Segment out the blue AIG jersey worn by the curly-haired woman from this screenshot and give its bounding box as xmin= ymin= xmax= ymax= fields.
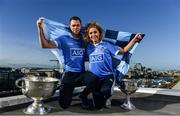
xmin=87 ymin=41 xmax=120 ymax=78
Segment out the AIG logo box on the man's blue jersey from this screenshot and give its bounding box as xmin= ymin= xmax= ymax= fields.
xmin=70 ymin=48 xmax=84 ymax=57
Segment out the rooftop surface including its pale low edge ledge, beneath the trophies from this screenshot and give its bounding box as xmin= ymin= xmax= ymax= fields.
xmin=0 ymin=88 xmax=180 ymax=115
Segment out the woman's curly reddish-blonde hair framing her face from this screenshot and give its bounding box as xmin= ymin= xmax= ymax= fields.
xmin=84 ymin=22 xmax=103 ymax=42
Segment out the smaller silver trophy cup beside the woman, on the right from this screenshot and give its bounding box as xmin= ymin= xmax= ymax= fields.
xmin=120 ymin=79 xmax=137 ymax=110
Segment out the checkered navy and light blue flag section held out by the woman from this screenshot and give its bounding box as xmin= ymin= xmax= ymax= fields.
xmin=105 ymin=30 xmax=145 ymax=83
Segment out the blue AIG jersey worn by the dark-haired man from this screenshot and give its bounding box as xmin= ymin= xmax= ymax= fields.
xmin=54 ymin=36 xmax=85 ymax=72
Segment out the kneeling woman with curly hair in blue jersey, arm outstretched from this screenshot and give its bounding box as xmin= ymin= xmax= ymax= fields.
xmin=81 ymin=22 xmax=142 ymax=109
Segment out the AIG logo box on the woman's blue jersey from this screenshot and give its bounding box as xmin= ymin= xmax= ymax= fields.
xmin=89 ymin=54 xmax=104 ymax=63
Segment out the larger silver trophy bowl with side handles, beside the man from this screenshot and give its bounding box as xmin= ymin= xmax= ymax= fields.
xmin=16 ymin=76 xmax=59 ymax=114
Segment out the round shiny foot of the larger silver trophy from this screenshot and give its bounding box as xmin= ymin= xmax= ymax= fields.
xmin=23 ymin=104 xmax=51 ymax=115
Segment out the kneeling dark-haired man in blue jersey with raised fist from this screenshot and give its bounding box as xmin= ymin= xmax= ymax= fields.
xmin=37 ymin=16 xmax=85 ymax=109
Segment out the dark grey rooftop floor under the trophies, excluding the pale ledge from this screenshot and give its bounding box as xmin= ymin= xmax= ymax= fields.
xmin=0 ymin=88 xmax=180 ymax=115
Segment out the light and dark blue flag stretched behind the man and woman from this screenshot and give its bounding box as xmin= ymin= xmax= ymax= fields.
xmin=43 ymin=18 xmax=144 ymax=82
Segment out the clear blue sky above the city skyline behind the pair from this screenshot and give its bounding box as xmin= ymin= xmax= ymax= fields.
xmin=0 ymin=0 xmax=180 ymax=70
